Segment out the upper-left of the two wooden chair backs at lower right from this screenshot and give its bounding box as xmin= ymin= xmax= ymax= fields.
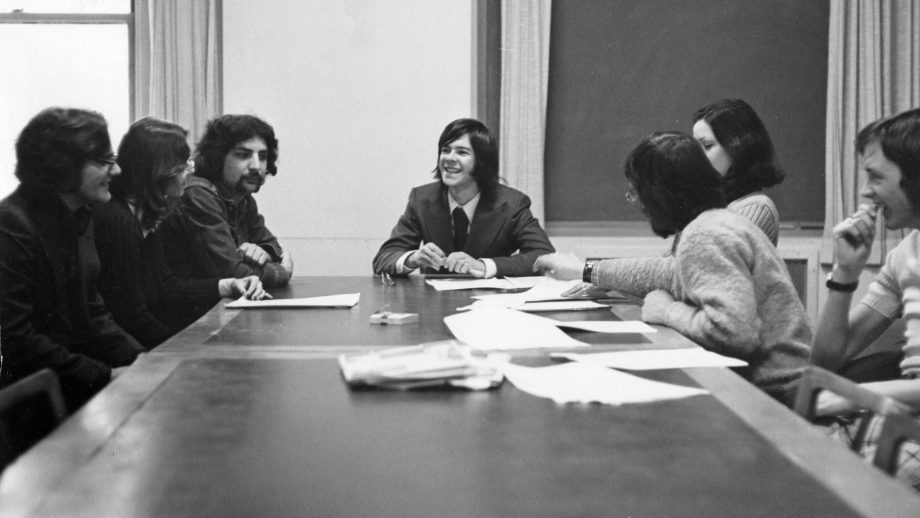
xmin=792 ymin=365 xmax=909 ymax=451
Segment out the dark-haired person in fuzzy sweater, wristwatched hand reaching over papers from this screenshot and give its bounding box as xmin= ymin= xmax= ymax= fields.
xmin=534 ymin=132 xmax=812 ymax=404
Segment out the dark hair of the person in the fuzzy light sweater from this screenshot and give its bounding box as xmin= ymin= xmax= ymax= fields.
xmin=623 ymin=131 xmax=725 ymax=241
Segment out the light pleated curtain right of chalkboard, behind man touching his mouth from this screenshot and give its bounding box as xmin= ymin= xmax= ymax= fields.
xmin=822 ymin=0 xmax=920 ymax=262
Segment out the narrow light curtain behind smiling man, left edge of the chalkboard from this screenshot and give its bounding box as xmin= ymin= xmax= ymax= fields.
xmin=499 ymin=0 xmax=552 ymax=223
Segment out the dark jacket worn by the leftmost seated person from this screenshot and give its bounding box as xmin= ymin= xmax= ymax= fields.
xmin=0 ymin=185 xmax=146 ymax=409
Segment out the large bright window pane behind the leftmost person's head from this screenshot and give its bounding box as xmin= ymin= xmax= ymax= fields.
xmin=0 ymin=24 xmax=130 ymax=197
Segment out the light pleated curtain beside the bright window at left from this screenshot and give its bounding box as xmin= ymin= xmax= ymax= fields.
xmin=134 ymin=0 xmax=222 ymax=143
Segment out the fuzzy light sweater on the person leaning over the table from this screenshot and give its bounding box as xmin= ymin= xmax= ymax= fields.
xmin=595 ymin=209 xmax=813 ymax=403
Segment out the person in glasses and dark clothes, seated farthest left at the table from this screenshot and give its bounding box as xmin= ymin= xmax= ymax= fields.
xmin=0 ymin=108 xmax=145 ymax=411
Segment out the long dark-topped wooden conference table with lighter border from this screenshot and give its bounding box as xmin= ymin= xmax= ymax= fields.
xmin=0 ymin=278 xmax=920 ymax=517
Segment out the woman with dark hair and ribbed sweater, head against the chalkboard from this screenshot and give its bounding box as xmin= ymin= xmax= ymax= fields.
xmin=693 ymin=99 xmax=786 ymax=245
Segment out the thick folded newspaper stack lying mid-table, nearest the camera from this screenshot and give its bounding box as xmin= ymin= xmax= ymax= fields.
xmin=339 ymin=341 xmax=504 ymax=390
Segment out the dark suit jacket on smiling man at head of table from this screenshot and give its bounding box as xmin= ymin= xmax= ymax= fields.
xmin=374 ymin=181 xmax=555 ymax=276
